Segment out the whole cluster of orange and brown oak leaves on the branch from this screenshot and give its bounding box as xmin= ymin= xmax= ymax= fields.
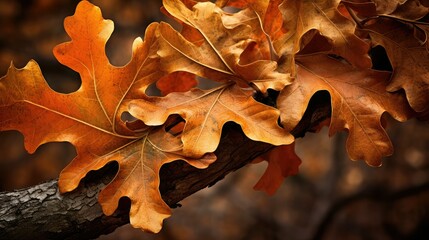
xmin=0 ymin=0 xmax=429 ymax=232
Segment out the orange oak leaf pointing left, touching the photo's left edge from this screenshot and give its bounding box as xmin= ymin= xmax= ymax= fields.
xmin=0 ymin=61 xmax=129 ymax=158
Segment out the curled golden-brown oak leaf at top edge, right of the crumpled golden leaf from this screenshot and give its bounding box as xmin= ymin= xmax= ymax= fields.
xmin=274 ymin=0 xmax=371 ymax=73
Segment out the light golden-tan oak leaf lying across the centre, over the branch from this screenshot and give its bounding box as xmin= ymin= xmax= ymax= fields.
xmin=129 ymin=84 xmax=294 ymax=158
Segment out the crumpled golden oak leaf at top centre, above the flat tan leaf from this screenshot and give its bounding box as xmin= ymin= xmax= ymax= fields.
xmin=157 ymin=0 xmax=291 ymax=92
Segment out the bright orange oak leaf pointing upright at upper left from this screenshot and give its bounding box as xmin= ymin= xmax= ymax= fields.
xmin=54 ymin=1 xmax=161 ymax=134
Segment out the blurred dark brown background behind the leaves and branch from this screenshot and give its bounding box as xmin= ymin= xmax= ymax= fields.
xmin=0 ymin=0 xmax=429 ymax=240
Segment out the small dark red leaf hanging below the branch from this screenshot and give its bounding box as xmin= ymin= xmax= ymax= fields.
xmin=253 ymin=143 xmax=301 ymax=195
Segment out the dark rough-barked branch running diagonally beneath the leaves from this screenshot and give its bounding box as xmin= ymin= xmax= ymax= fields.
xmin=0 ymin=94 xmax=330 ymax=239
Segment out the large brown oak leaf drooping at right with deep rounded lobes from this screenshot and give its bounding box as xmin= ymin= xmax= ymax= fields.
xmin=277 ymin=55 xmax=411 ymax=166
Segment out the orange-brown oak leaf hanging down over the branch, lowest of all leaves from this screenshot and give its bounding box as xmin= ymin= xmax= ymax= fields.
xmin=89 ymin=128 xmax=216 ymax=232
